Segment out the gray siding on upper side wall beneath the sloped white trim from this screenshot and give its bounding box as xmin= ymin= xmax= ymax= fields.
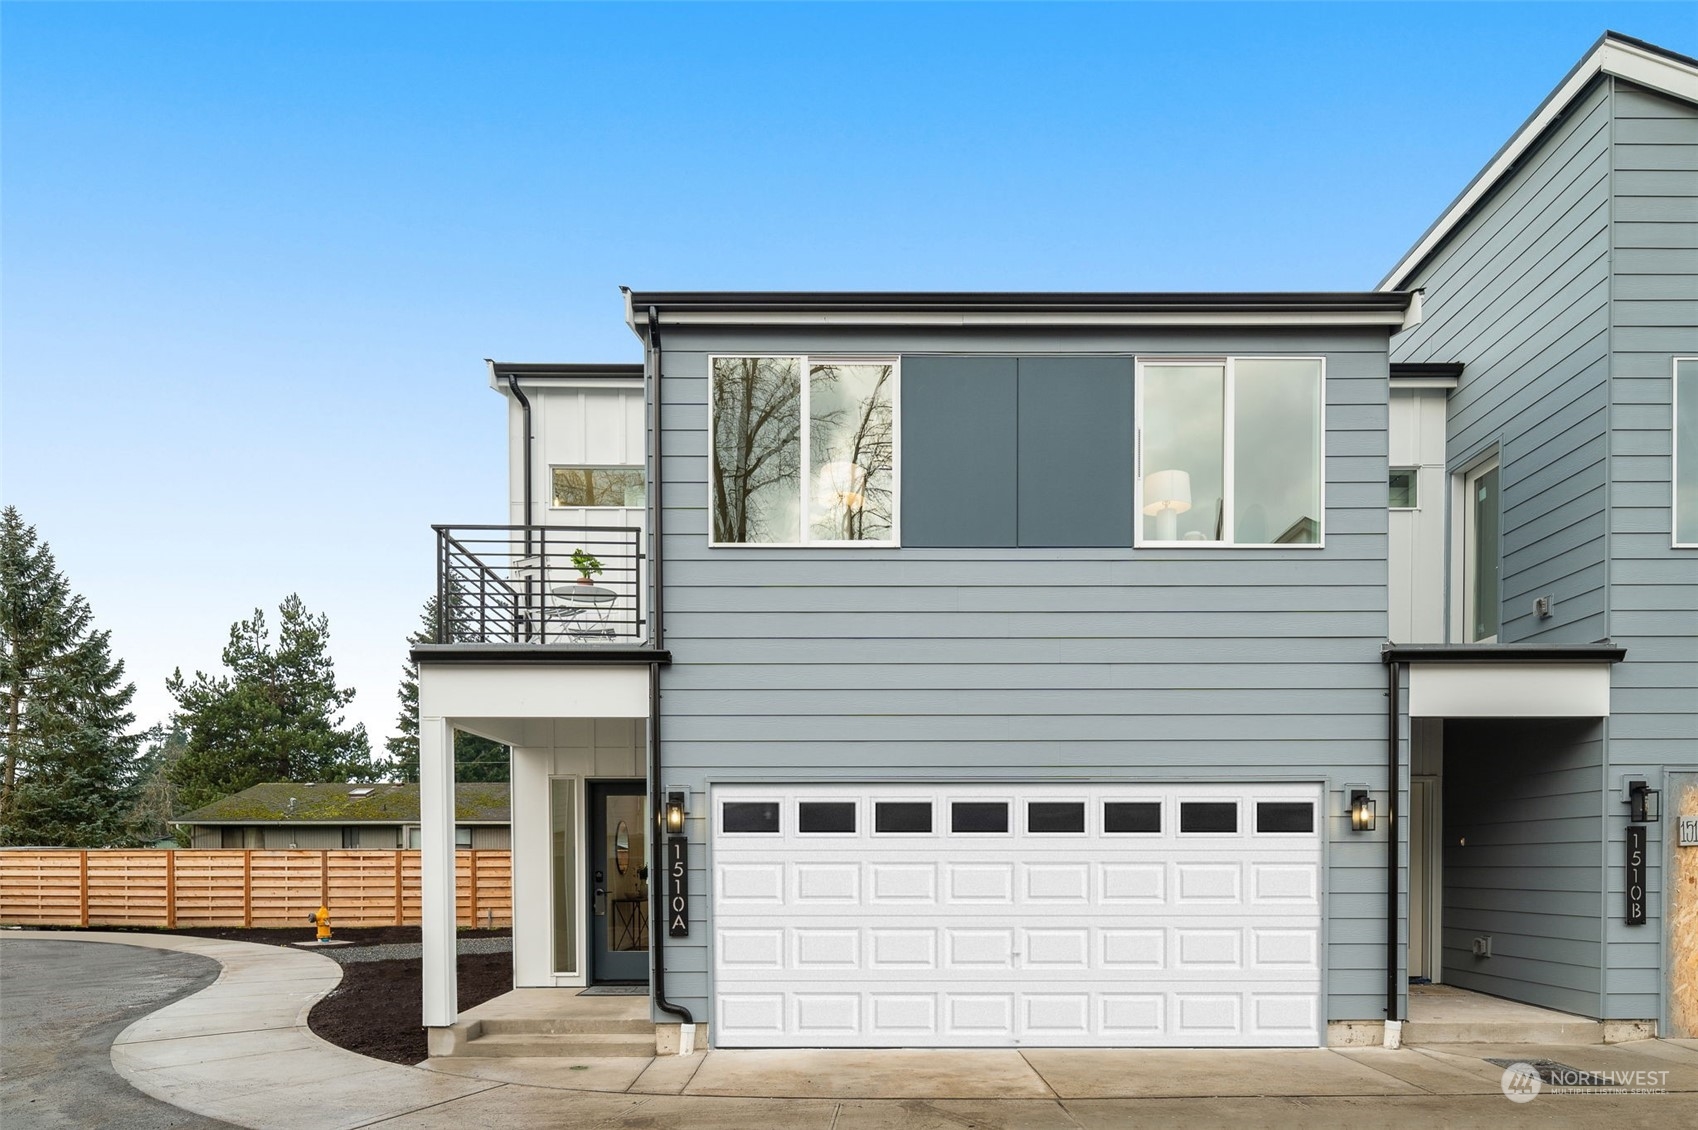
xmin=1392 ymin=83 xmax=1611 ymax=642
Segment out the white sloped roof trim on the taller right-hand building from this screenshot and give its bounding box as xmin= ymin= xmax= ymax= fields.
xmin=1375 ymin=36 xmax=1698 ymax=291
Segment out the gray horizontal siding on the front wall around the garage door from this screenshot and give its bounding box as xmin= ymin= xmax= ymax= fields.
xmin=659 ymin=328 xmax=1387 ymax=1018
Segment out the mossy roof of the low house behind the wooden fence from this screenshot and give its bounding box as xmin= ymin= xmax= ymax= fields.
xmin=173 ymin=782 xmax=509 ymax=824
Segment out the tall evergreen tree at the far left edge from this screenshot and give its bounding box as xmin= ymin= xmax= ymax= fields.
xmin=0 ymin=506 xmax=138 ymax=848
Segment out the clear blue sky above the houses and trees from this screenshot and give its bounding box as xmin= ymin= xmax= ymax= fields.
xmin=0 ymin=2 xmax=1698 ymax=746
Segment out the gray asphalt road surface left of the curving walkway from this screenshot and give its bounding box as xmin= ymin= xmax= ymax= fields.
xmin=0 ymin=936 xmax=228 ymax=1130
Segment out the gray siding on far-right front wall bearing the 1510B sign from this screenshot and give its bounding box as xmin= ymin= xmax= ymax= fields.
xmin=1605 ymin=82 xmax=1698 ymax=1018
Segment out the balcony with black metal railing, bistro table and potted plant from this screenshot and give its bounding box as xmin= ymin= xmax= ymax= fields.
xmin=431 ymin=525 xmax=649 ymax=647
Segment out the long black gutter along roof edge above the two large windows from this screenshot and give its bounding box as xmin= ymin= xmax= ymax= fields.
xmin=628 ymin=291 xmax=1411 ymax=314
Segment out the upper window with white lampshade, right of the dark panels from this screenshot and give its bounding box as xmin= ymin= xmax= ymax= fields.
xmin=1134 ymin=357 xmax=1324 ymax=545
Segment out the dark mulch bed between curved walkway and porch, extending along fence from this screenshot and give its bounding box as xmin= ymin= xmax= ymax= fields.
xmin=26 ymin=926 xmax=513 ymax=1064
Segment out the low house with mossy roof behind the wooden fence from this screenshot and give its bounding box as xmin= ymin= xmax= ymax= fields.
xmin=171 ymin=782 xmax=511 ymax=848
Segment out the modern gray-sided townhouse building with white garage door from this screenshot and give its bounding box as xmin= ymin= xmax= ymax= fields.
xmin=413 ymin=28 xmax=1698 ymax=1047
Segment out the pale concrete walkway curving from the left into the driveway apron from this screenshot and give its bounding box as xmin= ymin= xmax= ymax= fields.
xmin=0 ymin=933 xmax=1698 ymax=1130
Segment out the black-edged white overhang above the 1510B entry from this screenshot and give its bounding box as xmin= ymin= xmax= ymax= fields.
xmin=1380 ymin=642 xmax=1627 ymax=719
